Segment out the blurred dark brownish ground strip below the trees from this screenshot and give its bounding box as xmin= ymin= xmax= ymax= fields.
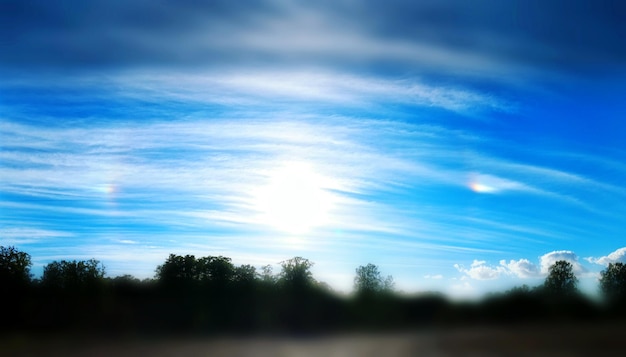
xmin=0 ymin=324 xmax=626 ymax=357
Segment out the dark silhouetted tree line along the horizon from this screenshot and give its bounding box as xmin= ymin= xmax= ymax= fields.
xmin=0 ymin=246 xmax=626 ymax=333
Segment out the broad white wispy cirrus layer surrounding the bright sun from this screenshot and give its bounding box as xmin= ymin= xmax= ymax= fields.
xmin=0 ymin=103 xmax=620 ymax=284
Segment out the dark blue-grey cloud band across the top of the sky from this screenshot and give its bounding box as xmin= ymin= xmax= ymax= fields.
xmin=0 ymin=0 xmax=626 ymax=78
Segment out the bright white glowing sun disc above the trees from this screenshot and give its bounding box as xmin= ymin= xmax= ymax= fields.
xmin=255 ymin=163 xmax=332 ymax=234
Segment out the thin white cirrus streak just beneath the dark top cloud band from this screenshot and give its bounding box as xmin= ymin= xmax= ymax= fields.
xmin=1 ymin=66 xmax=508 ymax=114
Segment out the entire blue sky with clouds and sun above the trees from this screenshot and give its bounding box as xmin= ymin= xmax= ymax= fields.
xmin=0 ymin=0 xmax=626 ymax=296
